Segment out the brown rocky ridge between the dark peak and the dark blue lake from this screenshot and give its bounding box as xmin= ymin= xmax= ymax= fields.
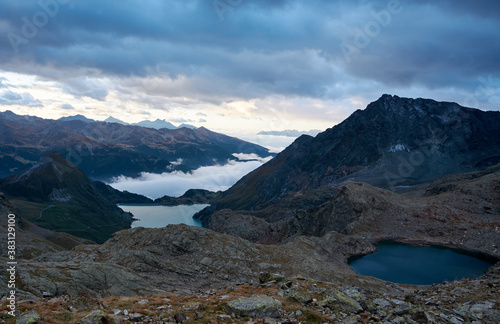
xmin=208 ymin=164 xmax=500 ymax=257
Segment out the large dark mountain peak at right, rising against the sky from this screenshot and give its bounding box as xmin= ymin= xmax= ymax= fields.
xmin=202 ymin=95 xmax=500 ymax=218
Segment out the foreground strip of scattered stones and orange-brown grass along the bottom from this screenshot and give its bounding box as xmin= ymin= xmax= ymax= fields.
xmin=1 ymin=264 xmax=500 ymax=324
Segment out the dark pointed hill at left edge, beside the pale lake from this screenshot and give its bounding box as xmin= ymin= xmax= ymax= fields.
xmin=0 ymin=153 xmax=132 ymax=243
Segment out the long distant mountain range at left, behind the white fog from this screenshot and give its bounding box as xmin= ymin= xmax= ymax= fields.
xmin=0 ymin=111 xmax=269 ymax=180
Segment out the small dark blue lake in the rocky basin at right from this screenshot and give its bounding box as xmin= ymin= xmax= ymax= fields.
xmin=349 ymin=242 xmax=493 ymax=285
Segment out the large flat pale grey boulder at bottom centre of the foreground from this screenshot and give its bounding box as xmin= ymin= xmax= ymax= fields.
xmin=226 ymin=295 xmax=281 ymax=318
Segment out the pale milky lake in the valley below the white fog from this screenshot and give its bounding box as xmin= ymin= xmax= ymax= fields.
xmin=118 ymin=204 xmax=209 ymax=228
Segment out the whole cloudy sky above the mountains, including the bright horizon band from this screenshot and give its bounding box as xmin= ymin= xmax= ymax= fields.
xmin=0 ymin=0 xmax=500 ymax=134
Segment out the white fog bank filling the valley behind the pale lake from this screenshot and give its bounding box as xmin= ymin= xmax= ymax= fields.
xmin=109 ymin=158 xmax=271 ymax=199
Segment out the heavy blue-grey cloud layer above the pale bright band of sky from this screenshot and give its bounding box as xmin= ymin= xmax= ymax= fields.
xmin=0 ymin=0 xmax=500 ymax=109
